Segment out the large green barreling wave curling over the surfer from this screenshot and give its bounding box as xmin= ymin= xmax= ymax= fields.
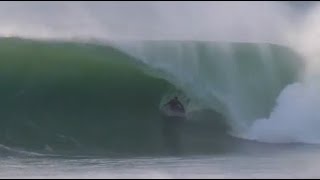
xmin=0 ymin=38 xmax=303 ymax=155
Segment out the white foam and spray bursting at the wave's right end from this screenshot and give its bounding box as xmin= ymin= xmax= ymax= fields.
xmin=245 ymin=3 xmax=320 ymax=143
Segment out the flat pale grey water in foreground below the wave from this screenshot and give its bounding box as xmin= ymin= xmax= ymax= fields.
xmin=0 ymin=145 xmax=320 ymax=179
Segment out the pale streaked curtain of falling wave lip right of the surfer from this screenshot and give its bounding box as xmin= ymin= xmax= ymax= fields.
xmin=114 ymin=41 xmax=303 ymax=136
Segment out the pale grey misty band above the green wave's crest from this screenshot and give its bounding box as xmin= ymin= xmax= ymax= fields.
xmin=0 ymin=2 xmax=292 ymax=42
